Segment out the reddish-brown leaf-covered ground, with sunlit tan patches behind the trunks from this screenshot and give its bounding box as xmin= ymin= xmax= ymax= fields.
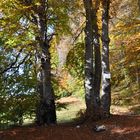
xmin=0 ymin=97 xmax=140 ymax=140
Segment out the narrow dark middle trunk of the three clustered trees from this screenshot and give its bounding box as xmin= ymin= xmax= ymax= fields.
xmin=91 ymin=3 xmax=102 ymax=115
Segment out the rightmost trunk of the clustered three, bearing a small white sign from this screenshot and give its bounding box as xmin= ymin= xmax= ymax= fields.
xmin=101 ymin=0 xmax=111 ymax=117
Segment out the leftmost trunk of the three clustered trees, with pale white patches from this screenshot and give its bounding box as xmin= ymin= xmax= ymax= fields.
xmin=83 ymin=0 xmax=93 ymax=117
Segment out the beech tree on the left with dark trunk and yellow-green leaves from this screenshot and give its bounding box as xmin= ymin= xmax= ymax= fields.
xmin=0 ymin=0 xmax=72 ymax=124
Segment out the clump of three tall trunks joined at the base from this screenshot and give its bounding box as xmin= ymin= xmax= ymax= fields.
xmin=83 ymin=0 xmax=111 ymax=119
